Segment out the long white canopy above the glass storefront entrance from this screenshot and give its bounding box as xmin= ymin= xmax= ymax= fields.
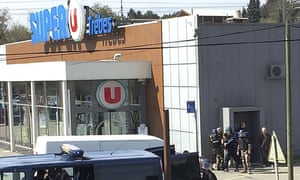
xmin=0 ymin=60 xmax=151 ymax=81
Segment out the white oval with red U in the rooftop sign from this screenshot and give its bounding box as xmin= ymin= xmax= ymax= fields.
xmin=68 ymin=0 xmax=85 ymax=41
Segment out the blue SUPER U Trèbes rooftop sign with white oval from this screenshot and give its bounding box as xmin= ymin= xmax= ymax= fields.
xmin=30 ymin=0 xmax=113 ymax=44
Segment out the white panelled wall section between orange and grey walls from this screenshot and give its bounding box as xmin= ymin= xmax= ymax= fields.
xmin=162 ymin=16 xmax=201 ymax=154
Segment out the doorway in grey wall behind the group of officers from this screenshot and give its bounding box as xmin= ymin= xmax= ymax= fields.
xmin=222 ymin=107 xmax=263 ymax=163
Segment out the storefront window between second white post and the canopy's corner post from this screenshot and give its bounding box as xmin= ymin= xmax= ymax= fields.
xmin=35 ymin=82 xmax=64 ymax=136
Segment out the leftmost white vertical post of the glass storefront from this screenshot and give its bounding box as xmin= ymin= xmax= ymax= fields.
xmin=7 ymin=81 xmax=15 ymax=152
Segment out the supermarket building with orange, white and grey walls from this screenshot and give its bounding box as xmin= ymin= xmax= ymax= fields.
xmin=0 ymin=2 xmax=300 ymax=161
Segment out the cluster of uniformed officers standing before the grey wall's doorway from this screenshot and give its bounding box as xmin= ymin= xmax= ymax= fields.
xmin=210 ymin=122 xmax=258 ymax=174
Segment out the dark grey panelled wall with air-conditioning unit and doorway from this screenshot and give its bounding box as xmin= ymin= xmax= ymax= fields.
xmin=198 ymin=24 xmax=300 ymax=158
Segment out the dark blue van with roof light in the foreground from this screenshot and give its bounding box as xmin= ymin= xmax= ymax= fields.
xmin=0 ymin=145 xmax=163 ymax=180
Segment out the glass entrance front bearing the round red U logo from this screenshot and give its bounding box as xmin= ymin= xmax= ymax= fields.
xmin=72 ymin=80 xmax=145 ymax=135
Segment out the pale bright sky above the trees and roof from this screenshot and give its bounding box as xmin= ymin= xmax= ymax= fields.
xmin=0 ymin=0 xmax=267 ymax=27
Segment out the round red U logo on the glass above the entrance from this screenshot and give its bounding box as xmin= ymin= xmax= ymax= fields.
xmin=96 ymin=81 xmax=127 ymax=109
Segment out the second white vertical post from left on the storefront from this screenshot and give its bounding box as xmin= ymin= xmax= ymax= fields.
xmin=30 ymin=81 xmax=38 ymax=149
